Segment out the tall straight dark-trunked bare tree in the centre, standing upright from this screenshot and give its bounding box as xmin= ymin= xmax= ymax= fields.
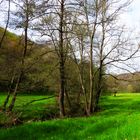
xmin=35 ymin=0 xmax=80 ymax=117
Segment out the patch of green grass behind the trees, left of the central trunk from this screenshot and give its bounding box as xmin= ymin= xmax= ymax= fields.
xmin=0 ymin=95 xmax=55 ymax=121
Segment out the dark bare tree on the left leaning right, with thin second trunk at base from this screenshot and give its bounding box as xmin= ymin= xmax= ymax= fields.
xmin=0 ymin=0 xmax=40 ymax=111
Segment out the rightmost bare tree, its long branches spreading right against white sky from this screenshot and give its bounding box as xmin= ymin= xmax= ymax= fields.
xmin=94 ymin=0 xmax=139 ymax=111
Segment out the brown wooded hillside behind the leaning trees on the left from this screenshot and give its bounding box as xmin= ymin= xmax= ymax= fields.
xmin=0 ymin=28 xmax=57 ymax=92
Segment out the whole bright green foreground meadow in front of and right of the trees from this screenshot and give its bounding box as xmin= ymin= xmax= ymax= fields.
xmin=0 ymin=94 xmax=140 ymax=140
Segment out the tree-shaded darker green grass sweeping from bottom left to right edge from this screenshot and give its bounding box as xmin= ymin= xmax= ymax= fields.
xmin=0 ymin=97 xmax=140 ymax=140
